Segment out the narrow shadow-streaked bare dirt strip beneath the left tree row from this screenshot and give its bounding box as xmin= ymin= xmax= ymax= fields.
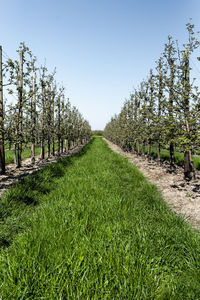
xmin=0 ymin=146 xmax=83 ymax=197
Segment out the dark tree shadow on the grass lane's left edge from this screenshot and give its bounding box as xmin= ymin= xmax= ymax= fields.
xmin=0 ymin=141 xmax=93 ymax=247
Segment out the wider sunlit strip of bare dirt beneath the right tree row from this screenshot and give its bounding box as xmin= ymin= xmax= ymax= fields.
xmin=105 ymin=139 xmax=200 ymax=229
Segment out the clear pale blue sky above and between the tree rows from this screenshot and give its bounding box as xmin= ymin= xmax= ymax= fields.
xmin=0 ymin=0 xmax=200 ymax=129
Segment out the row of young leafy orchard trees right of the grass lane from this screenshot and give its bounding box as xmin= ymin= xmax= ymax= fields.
xmin=104 ymin=23 xmax=200 ymax=179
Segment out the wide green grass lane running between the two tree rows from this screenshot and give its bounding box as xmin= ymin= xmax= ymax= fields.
xmin=0 ymin=138 xmax=200 ymax=300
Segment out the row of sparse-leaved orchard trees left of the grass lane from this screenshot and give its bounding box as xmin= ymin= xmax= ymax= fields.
xmin=0 ymin=43 xmax=91 ymax=174
